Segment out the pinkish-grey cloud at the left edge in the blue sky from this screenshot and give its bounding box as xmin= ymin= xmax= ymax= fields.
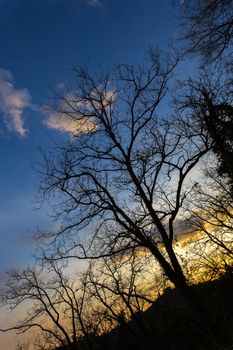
xmin=0 ymin=69 xmax=31 ymax=136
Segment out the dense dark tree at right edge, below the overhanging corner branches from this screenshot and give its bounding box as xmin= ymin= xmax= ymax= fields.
xmin=177 ymin=69 xmax=233 ymax=188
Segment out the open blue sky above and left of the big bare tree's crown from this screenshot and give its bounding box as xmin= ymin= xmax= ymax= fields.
xmin=0 ymin=0 xmax=178 ymax=350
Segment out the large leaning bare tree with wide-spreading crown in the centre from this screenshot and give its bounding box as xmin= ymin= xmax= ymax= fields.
xmin=36 ymin=51 xmax=213 ymax=295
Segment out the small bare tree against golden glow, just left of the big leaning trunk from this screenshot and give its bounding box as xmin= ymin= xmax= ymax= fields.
xmin=87 ymin=252 xmax=159 ymax=329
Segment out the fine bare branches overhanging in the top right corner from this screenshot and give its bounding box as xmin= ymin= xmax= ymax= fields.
xmin=179 ymin=0 xmax=233 ymax=63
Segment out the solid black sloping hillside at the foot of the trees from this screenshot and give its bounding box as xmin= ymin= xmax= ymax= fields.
xmin=53 ymin=272 xmax=233 ymax=350
